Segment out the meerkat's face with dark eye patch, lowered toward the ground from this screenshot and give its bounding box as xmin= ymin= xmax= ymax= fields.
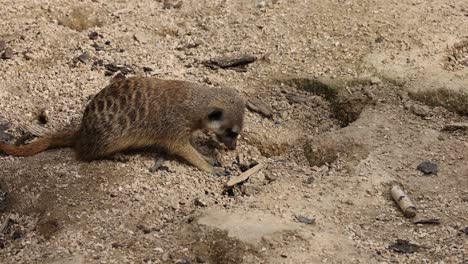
xmin=205 ymin=105 xmax=244 ymax=150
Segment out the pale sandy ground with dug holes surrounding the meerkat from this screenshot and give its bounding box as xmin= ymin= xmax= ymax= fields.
xmin=0 ymin=0 xmax=468 ymax=264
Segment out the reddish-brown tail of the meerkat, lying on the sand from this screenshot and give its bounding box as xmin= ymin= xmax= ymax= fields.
xmin=0 ymin=131 xmax=76 ymax=157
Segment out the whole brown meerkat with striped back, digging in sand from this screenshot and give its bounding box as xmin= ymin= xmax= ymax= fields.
xmin=0 ymin=77 xmax=245 ymax=174
